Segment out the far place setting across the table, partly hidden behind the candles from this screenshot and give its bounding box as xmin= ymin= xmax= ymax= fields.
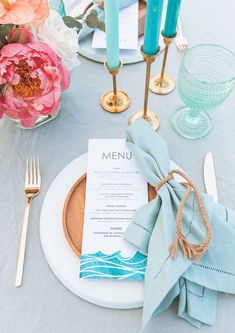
xmin=70 ymin=0 xmax=188 ymax=64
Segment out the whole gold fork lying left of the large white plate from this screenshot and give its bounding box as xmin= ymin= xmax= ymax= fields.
xmin=15 ymin=157 xmax=41 ymax=287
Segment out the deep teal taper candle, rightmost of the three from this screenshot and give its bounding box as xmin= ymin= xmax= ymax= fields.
xmin=163 ymin=0 xmax=181 ymax=38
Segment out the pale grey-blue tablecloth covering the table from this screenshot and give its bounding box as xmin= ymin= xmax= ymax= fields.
xmin=0 ymin=0 xmax=235 ymax=333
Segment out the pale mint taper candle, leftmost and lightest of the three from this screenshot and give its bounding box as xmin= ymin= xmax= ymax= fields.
xmin=104 ymin=0 xmax=119 ymax=69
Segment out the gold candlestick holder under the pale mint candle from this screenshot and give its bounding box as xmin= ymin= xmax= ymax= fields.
xmin=100 ymin=62 xmax=130 ymax=113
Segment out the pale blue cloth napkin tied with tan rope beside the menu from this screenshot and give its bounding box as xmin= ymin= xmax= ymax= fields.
xmin=125 ymin=120 xmax=235 ymax=327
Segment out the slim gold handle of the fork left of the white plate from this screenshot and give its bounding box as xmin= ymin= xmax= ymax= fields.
xmin=15 ymin=198 xmax=32 ymax=287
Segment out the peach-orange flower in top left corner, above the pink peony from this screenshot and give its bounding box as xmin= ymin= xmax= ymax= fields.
xmin=0 ymin=0 xmax=50 ymax=26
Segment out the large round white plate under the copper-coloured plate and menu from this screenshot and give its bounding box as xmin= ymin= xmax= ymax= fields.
xmin=40 ymin=154 xmax=178 ymax=309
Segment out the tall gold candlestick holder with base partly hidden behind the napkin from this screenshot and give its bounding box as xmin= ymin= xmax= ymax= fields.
xmin=128 ymin=46 xmax=160 ymax=130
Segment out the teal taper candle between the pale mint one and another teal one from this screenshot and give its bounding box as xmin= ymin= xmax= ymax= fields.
xmin=143 ymin=0 xmax=163 ymax=55
